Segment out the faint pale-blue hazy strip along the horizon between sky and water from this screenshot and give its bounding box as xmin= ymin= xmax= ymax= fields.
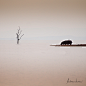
xmin=0 ymin=34 xmax=86 ymax=40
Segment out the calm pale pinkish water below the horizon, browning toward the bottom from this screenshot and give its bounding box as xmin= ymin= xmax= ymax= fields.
xmin=0 ymin=40 xmax=86 ymax=86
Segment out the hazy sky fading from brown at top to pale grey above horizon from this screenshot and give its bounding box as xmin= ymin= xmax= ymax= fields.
xmin=0 ymin=0 xmax=86 ymax=38
